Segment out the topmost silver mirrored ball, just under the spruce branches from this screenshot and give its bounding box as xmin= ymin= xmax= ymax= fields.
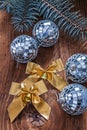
xmin=33 ymin=20 xmax=59 ymax=47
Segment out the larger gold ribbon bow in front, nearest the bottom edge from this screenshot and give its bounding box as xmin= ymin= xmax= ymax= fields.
xmin=8 ymin=78 xmax=51 ymax=122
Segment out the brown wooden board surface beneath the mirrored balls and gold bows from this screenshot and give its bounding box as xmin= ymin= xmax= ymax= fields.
xmin=0 ymin=0 xmax=87 ymax=130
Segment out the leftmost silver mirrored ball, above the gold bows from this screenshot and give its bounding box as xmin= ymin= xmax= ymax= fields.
xmin=10 ymin=35 xmax=38 ymax=63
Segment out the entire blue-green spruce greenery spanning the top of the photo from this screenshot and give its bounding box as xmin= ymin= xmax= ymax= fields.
xmin=0 ymin=0 xmax=87 ymax=40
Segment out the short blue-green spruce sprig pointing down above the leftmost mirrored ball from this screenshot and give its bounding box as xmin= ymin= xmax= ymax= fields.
xmin=12 ymin=0 xmax=39 ymax=32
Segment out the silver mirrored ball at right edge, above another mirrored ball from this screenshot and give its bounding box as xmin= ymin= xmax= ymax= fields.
xmin=65 ymin=54 xmax=87 ymax=83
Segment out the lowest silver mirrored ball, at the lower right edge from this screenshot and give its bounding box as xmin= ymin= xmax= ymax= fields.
xmin=58 ymin=83 xmax=87 ymax=115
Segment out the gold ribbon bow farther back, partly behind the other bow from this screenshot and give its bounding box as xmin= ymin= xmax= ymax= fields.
xmin=26 ymin=59 xmax=66 ymax=91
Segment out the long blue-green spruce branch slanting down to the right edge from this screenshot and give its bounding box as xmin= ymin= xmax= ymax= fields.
xmin=40 ymin=0 xmax=87 ymax=39
